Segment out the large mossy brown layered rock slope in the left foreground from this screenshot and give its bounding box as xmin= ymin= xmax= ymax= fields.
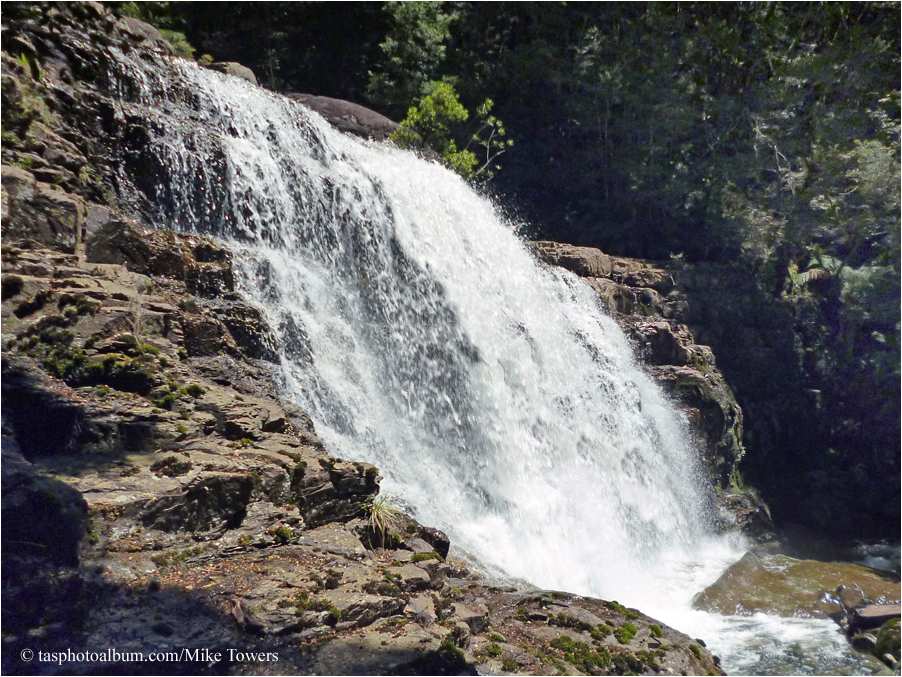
xmin=2 ymin=222 xmax=717 ymax=674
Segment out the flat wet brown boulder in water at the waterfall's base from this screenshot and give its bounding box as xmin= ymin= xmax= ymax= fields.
xmin=693 ymin=552 xmax=900 ymax=619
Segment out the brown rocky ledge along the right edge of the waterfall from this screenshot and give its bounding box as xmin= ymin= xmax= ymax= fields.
xmin=532 ymin=241 xmax=775 ymax=543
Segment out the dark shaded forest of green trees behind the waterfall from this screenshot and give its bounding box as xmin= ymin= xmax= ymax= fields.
xmin=111 ymin=2 xmax=900 ymax=537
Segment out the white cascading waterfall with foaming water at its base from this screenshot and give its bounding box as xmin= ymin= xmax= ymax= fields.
xmin=118 ymin=58 xmax=896 ymax=674
